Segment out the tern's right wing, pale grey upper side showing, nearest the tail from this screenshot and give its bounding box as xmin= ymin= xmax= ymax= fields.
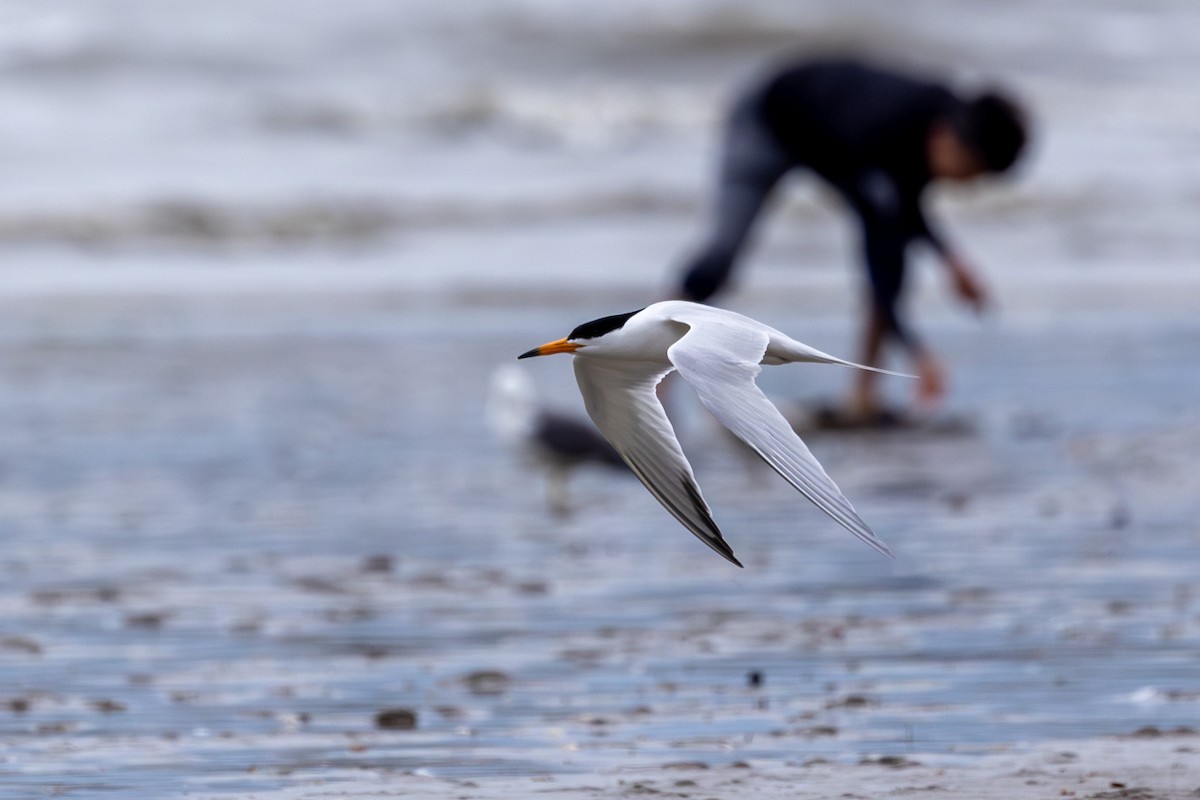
xmin=667 ymin=320 xmax=892 ymax=555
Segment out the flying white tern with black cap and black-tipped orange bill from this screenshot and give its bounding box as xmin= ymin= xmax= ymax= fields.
xmin=517 ymin=300 xmax=896 ymax=566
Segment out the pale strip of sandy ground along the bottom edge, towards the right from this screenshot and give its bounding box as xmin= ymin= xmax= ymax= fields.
xmin=184 ymin=733 xmax=1200 ymax=800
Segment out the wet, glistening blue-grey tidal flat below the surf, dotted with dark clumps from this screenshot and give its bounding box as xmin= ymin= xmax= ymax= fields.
xmin=0 ymin=278 xmax=1200 ymax=798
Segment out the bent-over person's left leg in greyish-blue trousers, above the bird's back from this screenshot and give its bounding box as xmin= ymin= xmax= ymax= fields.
xmin=682 ymin=91 xmax=793 ymax=302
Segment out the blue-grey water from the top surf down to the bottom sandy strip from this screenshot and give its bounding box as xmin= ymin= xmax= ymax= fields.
xmin=0 ymin=0 xmax=1200 ymax=798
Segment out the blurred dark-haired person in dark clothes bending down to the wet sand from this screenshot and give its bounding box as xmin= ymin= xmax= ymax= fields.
xmin=678 ymin=59 xmax=1027 ymax=423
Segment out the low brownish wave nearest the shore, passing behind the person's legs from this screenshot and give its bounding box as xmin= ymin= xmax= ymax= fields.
xmin=0 ymin=184 xmax=1142 ymax=247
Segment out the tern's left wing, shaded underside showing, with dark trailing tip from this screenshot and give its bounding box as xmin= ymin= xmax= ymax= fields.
xmin=575 ymin=357 xmax=742 ymax=566
